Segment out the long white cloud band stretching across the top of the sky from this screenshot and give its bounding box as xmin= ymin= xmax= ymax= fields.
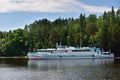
xmin=0 ymin=0 xmax=116 ymax=13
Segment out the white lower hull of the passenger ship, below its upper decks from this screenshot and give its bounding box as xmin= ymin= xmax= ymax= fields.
xmin=28 ymin=52 xmax=114 ymax=60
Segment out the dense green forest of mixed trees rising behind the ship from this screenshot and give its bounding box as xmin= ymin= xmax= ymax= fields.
xmin=0 ymin=7 xmax=120 ymax=57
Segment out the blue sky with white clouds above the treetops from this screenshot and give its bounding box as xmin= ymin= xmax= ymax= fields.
xmin=0 ymin=0 xmax=120 ymax=31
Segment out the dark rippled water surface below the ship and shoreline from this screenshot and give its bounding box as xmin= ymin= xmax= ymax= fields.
xmin=0 ymin=59 xmax=120 ymax=80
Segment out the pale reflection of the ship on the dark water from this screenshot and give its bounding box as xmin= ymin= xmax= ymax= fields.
xmin=28 ymin=59 xmax=114 ymax=70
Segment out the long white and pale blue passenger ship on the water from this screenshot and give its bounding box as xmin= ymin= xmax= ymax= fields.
xmin=28 ymin=46 xmax=114 ymax=60
